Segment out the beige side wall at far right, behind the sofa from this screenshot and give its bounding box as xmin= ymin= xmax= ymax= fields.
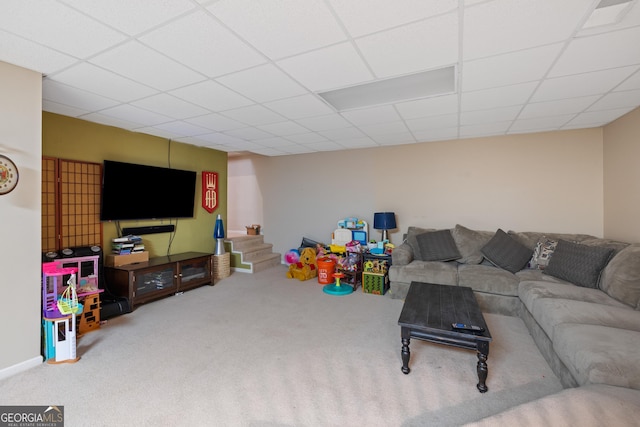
xmin=604 ymin=108 xmax=640 ymax=242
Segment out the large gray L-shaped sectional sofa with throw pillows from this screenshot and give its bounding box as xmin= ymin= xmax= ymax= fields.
xmin=389 ymin=225 xmax=640 ymax=420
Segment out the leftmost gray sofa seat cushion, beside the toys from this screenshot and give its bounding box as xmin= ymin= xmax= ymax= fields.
xmin=389 ymin=260 xmax=458 ymax=285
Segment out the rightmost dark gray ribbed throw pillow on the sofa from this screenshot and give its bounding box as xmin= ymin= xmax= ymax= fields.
xmin=543 ymin=240 xmax=613 ymax=288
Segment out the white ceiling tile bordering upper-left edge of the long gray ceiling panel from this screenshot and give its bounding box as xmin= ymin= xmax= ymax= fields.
xmin=277 ymin=43 xmax=373 ymax=91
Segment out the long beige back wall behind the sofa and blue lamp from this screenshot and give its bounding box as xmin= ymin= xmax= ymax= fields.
xmin=229 ymin=128 xmax=603 ymax=260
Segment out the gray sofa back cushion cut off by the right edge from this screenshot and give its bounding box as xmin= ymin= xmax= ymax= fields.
xmin=600 ymin=243 xmax=640 ymax=310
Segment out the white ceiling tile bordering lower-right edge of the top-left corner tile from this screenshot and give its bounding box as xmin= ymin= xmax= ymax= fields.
xmin=90 ymin=41 xmax=205 ymax=90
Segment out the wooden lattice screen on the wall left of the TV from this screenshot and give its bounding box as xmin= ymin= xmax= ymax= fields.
xmin=42 ymin=158 xmax=102 ymax=252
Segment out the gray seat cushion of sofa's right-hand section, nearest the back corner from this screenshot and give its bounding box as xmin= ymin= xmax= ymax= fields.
xmin=518 ymin=281 xmax=628 ymax=314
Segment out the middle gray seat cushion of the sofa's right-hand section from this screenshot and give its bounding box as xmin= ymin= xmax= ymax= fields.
xmin=529 ymin=298 xmax=640 ymax=345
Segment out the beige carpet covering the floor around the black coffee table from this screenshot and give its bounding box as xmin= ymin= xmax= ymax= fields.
xmin=0 ymin=266 xmax=562 ymax=426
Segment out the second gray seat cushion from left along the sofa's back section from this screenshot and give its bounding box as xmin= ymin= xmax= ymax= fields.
xmin=458 ymin=264 xmax=519 ymax=296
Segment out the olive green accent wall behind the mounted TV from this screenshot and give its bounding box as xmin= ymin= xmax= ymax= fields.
xmin=42 ymin=112 xmax=227 ymax=256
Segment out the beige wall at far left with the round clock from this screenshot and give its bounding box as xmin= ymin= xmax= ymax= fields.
xmin=0 ymin=62 xmax=42 ymax=379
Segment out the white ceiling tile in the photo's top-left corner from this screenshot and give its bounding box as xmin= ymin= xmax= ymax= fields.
xmin=0 ymin=0 xmax=125 ymax=58
